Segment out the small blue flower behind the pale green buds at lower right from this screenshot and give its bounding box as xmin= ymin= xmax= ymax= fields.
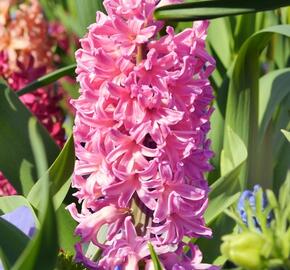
xmin=237 ymin=185 xmax=272 ymax=230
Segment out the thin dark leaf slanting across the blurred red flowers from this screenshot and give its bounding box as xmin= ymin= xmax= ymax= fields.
xmin=17 ymin=64 xmax=76 ymax=96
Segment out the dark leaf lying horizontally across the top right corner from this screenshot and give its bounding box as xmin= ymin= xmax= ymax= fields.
xmin=155 ymin=0 xmax=290 ymax=21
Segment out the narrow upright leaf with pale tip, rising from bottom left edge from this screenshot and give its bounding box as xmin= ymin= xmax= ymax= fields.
xmin=12 ymin=118 xmax=59 ymax=270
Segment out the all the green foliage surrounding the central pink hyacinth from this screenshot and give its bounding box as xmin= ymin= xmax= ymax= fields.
xmin=0 ymin=0 xmax=290 ymax=270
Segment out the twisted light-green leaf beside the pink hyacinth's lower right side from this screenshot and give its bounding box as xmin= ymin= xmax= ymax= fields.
xmin=197 ymin=127 xmax=247 ymax=262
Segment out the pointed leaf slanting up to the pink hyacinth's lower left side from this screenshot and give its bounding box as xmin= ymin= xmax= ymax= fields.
xmin=27 ymin=136 xmax=75 ymax=209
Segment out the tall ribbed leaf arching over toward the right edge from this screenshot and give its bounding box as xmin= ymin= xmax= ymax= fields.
xmin=224 ymin=25 xmax=290 ymax=186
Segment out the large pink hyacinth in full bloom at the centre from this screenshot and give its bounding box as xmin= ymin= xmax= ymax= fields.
xmin=68 ymin=0 xmax=215 ymax=269
